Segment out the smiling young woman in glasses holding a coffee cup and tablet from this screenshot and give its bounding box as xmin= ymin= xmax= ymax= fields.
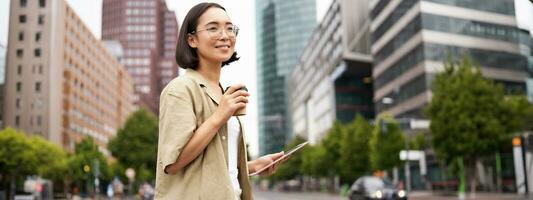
xmin=155 ymin=3 xmax=283 ymax=200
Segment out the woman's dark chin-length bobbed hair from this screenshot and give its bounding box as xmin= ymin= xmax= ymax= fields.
xmin=176 ymin=3 xmax=239 ymax=69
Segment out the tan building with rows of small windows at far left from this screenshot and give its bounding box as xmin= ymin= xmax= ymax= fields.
xmin=4 ymin=0 xmax=134 ymax=155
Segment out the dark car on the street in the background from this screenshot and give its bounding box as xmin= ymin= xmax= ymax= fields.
xmin=349 ymin=176 xmax=407 ymax=200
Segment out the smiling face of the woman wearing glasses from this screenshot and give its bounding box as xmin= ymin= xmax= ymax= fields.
xmin=188 ymin=8 xmax=236 ymax=63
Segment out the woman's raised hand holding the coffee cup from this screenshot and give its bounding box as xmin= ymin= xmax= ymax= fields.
xmin=214 ymin=84 xmax=250 ymax=123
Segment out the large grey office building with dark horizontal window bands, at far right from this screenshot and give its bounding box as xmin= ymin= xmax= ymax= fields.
xmin=370 ymin=0 xmax=530 ymax=118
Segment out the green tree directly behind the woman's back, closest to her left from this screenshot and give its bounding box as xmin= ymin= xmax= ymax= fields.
xmin=108 ymin=109 xmax=158 ymax=182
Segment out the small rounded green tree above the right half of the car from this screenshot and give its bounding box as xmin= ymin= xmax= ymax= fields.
xmin=370 ymin=116 xmax=405 ymax=170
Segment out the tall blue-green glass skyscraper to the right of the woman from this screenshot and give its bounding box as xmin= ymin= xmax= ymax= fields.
xmin=256 ymin=0 xmax=316 ymax=155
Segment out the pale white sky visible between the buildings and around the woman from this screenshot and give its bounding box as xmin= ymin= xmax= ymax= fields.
xmin=0 ymin=0 xmax=533 ymax=156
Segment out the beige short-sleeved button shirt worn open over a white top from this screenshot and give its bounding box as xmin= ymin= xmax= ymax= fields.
xmin=155 ymin=69 xmax=252 ymax=200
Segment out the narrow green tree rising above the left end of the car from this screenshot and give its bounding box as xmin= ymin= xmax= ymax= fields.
xmin=338 ymin=115 xmax=372 ymax=183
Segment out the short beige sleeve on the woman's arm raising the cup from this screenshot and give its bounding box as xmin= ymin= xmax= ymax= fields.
xmin=158 ymin=87 xmax=197 ymax=173
